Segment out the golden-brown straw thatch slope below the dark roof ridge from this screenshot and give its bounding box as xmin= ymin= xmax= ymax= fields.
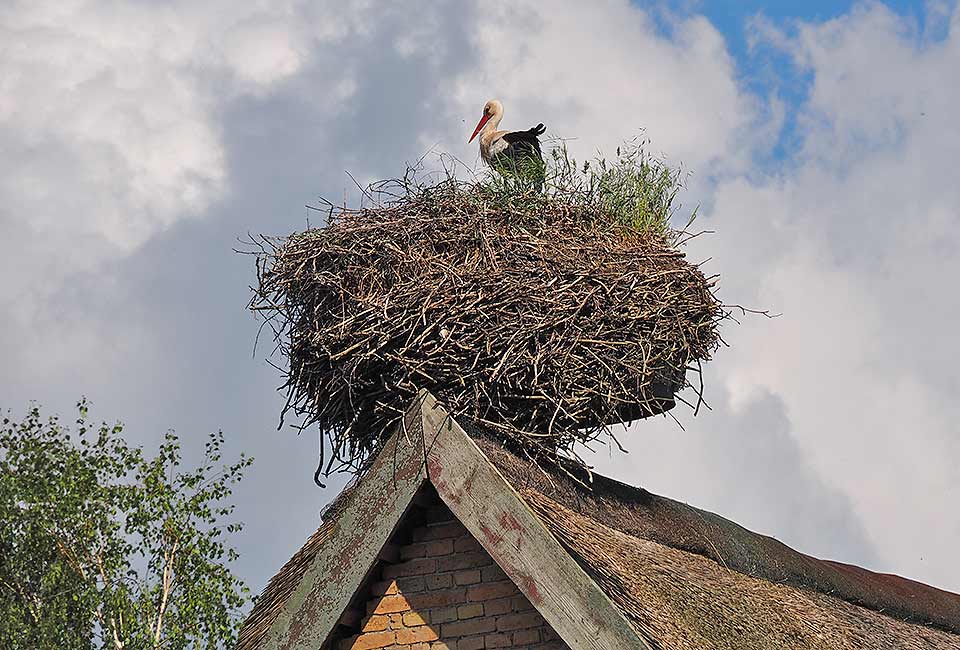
xmin=523 ymin=491 xmax=960 ymax=650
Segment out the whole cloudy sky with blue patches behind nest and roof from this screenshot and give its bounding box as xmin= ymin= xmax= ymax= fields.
xmin=0 ymin=0 xmax=960 ymax=591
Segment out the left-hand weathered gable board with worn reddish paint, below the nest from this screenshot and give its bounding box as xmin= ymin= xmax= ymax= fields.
xmin=265 ymin=400 xmax=426 ymax=650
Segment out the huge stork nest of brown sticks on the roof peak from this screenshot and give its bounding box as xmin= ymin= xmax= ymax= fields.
xmin=251 ymin=175 xmax=725 ymax=473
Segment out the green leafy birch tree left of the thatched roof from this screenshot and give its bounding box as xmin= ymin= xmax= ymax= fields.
xmin=0 ymin=402 xmax=252 ymax=650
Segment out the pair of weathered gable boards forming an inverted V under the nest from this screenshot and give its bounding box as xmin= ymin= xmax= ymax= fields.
xmin=256 ymin=392 xmax=649 ymax=650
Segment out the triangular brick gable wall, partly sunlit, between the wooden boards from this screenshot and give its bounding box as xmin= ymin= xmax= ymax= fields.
xmin=333 ymin=494 xmax=567 ymax=650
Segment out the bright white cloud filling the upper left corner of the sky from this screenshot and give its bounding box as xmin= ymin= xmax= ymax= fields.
xmin=0 ymin=0 xmax=352 ymax=271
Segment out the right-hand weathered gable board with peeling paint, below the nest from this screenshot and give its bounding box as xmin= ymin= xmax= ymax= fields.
xmin=423 ymin=395 xmax=649 ymax=650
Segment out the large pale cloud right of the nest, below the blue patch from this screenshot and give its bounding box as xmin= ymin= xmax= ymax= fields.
xmin=664 ymin=4 xmax=960 ymax=589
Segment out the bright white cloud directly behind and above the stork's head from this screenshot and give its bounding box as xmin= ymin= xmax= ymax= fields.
xmin=442 ymin=0 xmax=763 ymax=175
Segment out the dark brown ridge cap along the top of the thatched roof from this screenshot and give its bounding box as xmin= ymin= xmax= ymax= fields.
xmin=474 ymin=432 xmax=960 ymax=634
